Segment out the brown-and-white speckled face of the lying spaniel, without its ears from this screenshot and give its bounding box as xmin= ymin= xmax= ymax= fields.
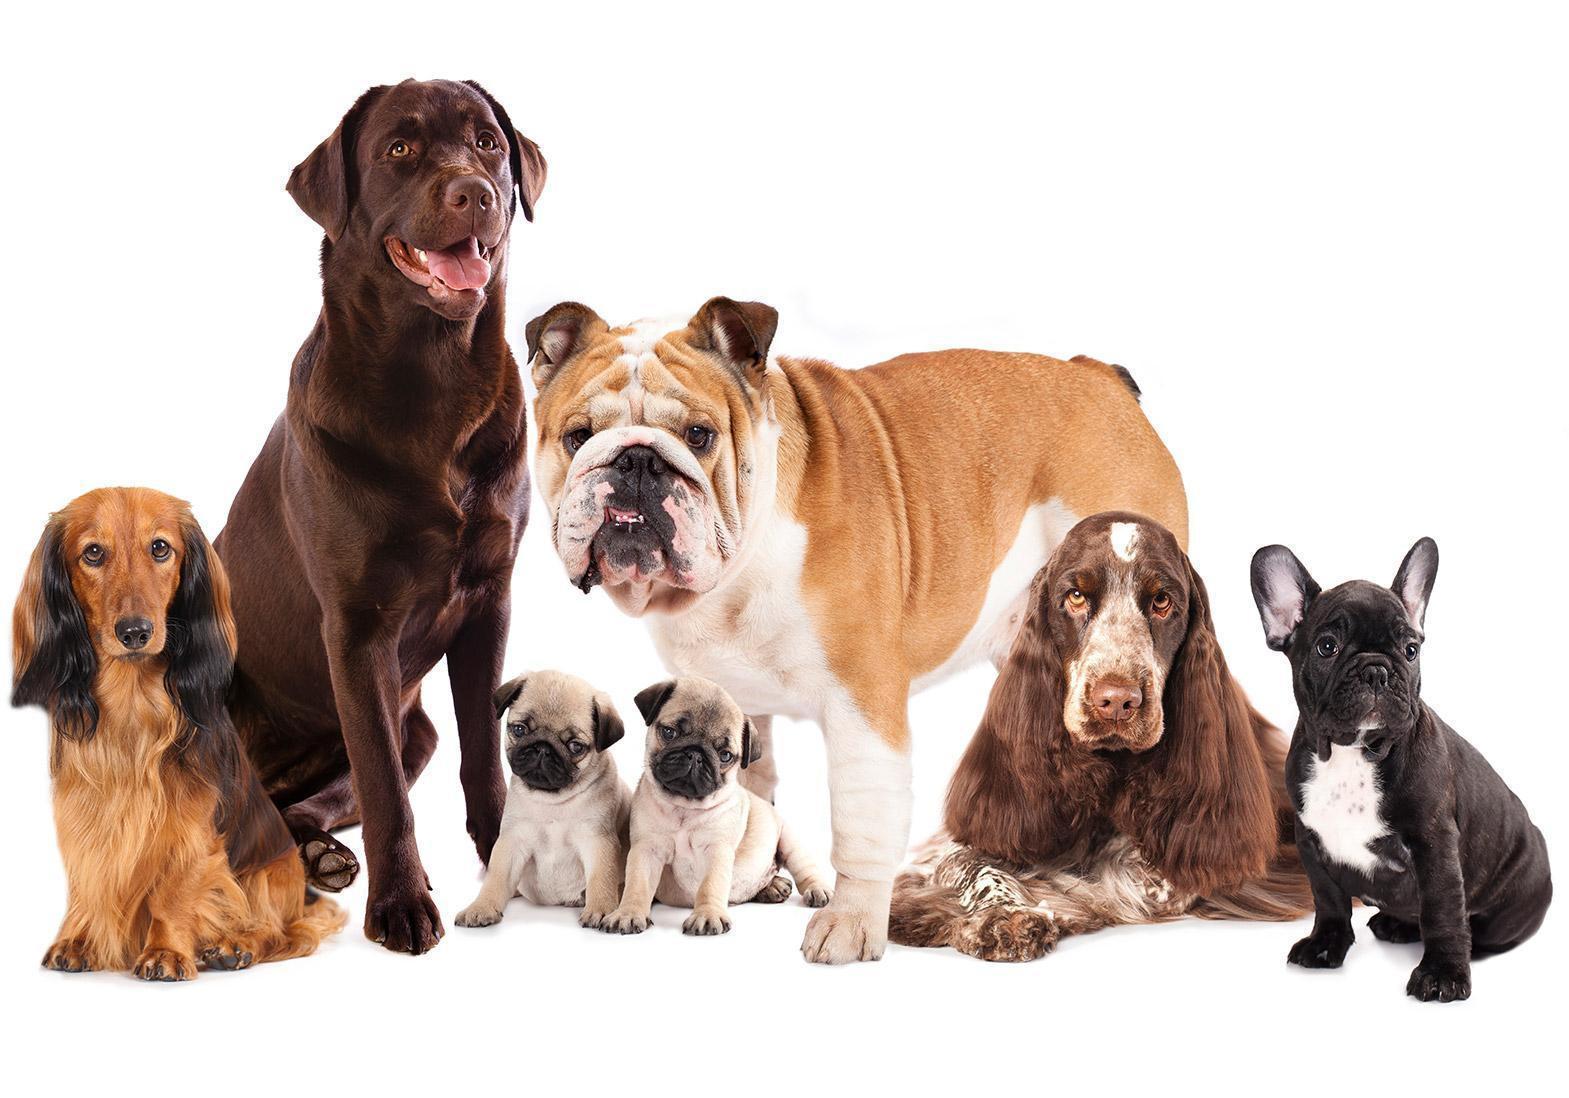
xmin=1040 ymin=511 xmax=1196 ymax=751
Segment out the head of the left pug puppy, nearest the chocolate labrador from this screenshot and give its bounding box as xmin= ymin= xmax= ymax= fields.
xmin=494 ymin=671 xmax=624 ymax=794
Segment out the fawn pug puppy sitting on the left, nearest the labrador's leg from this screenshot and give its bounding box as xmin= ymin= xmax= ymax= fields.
xmin=458 ymin=671 xmax=632 ymax=927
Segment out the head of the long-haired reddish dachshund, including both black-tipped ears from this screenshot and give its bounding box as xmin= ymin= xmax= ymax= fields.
xmin=11 ymin=488 xmax=235 ymax=736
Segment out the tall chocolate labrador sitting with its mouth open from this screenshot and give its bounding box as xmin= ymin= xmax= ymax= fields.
xmin=218 ymin=80 xmax=544 ymax=954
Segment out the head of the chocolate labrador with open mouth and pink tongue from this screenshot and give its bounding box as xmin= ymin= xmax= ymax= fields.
xmin=289 ymin=80 xmax=544 ymax=320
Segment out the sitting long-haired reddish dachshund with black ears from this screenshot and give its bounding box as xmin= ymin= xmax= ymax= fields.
xmin=11 ymin=488 xmax=344 ymax=980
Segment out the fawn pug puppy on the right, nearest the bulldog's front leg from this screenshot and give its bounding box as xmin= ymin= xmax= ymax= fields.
xmin=602 ymin=676 xmax=833 ymax=935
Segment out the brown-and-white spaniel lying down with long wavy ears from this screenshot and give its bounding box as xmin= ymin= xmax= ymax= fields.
xmin=891 ymin=511 xmax=1312 ymax=962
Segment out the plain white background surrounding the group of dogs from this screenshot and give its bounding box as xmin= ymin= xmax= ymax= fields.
xmin=0 ymin=0 xmax=1569 ymax=1093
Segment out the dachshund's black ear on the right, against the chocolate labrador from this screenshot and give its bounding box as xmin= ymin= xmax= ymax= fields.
xmin=163 ymin=518 xmax=235 ymax=731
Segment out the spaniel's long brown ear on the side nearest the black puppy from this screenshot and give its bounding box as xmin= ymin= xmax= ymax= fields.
xmin=1117 ymin=563 xmax=1279 ymax=894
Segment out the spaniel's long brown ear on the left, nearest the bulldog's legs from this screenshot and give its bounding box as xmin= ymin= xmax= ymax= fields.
xmin=943 ymin=569 xmax=1112 ymax=864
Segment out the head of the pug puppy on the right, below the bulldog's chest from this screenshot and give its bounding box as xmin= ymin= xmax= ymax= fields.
xmin=637 ymin=676 xmax=761 ymax=802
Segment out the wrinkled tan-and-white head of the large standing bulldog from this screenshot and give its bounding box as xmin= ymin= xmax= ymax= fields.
xmin=529 ymin=298 xmax=778 ymax=615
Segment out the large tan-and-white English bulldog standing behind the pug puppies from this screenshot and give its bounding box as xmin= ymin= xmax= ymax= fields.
xmin=527 ymin=298 xmax=1188 ymax=963
